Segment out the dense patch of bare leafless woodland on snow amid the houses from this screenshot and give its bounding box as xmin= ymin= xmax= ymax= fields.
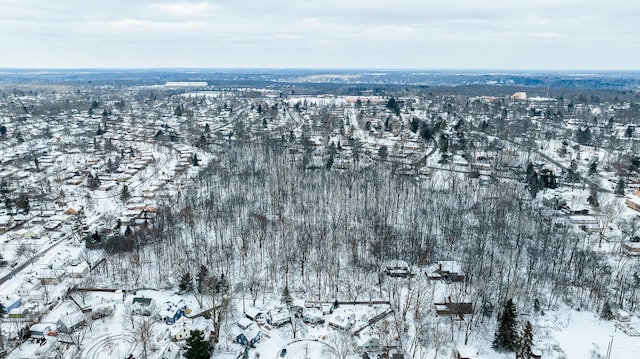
xmin=90 ymin=136 xmax=640 ymax=346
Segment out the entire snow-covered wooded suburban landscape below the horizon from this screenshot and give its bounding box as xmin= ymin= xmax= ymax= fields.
xmin=0 ymin=70 xmax=640 ymax=359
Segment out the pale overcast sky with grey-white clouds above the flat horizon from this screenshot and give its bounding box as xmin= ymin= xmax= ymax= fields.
xmin=0 ymin=0 xmax=640 ymax=70
